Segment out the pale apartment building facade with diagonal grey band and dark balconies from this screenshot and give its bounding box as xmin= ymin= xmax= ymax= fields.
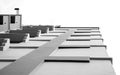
xmin=0 ymin=25 xmax=115 ymax=75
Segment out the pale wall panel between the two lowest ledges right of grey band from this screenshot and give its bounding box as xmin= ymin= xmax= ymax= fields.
xmin=50 ymin=47 xmax=108 ymax=57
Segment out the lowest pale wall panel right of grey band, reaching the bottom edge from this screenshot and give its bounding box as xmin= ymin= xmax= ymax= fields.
xmin=29 ymin=60 xmax=115 ymax=75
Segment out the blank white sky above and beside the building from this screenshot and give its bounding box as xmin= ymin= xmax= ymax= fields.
xmin=0 ymin=0 xmax=120 ymax=75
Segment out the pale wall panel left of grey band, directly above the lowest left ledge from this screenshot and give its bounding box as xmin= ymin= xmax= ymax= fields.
xmin=0 ymin=48 xmax=36 ymax=60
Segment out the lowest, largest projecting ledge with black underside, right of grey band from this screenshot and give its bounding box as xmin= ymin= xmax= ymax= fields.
xmin=44 ymin=56 xmax=112 ymax=63
